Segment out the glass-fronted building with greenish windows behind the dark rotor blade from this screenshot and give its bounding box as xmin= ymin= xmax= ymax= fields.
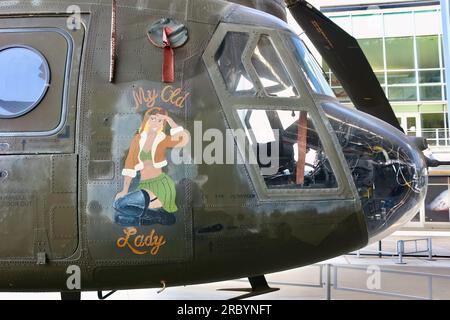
xmin=320 ymin=1 xmax=450 ymax=229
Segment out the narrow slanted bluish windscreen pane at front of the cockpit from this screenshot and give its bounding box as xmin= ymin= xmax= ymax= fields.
xmin=287 ymin=35 xmax=335 ymax=97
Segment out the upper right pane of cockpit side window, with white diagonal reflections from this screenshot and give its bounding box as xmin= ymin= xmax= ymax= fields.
xmin=251 ymin=34 xmax=298 ymax=98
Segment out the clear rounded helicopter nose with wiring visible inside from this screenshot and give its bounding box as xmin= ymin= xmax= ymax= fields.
xmin=323 ymin=103 xmax=428 ymax=243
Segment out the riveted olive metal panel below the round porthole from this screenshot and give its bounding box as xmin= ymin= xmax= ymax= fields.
xmin=0 ymin=155 xmax=77 ymax=260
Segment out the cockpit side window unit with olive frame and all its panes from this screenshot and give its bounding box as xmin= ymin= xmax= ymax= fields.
xmin=203 ymin=23 xmax=353 ymax=201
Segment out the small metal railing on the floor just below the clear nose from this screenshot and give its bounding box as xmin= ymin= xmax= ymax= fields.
xmin=356 ymin=238 xmax=433 ymax=264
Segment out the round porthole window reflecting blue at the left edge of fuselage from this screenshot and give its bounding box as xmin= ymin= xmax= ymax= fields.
xmin=0 ymin=46 xmax=50 ymax=118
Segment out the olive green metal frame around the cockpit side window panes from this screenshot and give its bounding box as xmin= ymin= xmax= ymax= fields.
xmin=203 ymin=23 xmax=357 ymax=201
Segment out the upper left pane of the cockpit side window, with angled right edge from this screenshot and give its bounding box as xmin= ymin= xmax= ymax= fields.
xmin=215 ymin=32 xmax=256 ymax=95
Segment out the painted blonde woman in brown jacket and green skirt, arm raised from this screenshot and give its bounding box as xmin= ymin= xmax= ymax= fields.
xmin=114 ymin=107 xmax=189 ymax=226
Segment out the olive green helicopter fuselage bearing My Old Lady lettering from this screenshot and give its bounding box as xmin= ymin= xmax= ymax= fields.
xmin=0 ymin=0 xmax=368 ymax=291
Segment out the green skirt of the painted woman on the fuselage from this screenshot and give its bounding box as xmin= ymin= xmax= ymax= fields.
xmin=139 ymin=173 xmax=178 ymax=213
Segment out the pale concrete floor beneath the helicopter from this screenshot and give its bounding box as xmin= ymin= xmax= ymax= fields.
xmin=0 ymin=232 xmax=450 ymax=300
